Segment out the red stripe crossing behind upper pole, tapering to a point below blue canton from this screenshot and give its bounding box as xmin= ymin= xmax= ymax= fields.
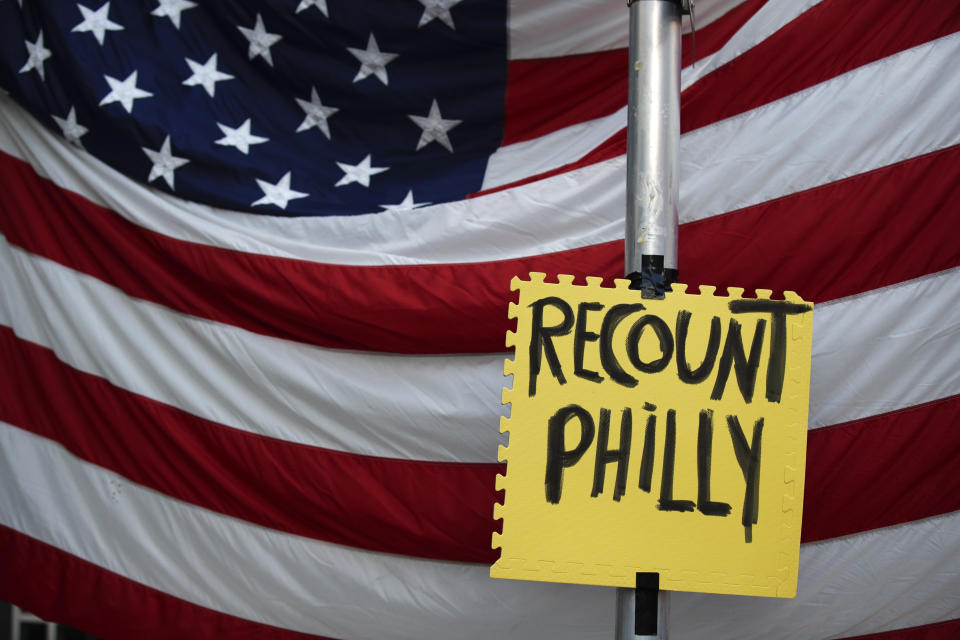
xmin=488 ymin=0 xmax=960 ymax=190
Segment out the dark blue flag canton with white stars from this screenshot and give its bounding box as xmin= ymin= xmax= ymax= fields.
xmin=0 ymin=0 xmax=506 ymax=216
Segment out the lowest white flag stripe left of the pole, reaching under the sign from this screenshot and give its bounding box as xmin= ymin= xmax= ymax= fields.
xmin=0 ymin=422 xmax=614 ymax=640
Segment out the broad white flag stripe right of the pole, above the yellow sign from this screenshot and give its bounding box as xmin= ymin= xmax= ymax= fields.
xmin=680 ymin=32 xmax=960 ymax=225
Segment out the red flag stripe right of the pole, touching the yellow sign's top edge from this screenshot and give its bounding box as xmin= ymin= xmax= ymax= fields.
xmin=679 ymin=146 xmax=960 ymax=302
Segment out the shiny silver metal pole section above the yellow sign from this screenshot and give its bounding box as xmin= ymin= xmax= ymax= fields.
xmin=625 ymin=0 xmax=681 ymax=282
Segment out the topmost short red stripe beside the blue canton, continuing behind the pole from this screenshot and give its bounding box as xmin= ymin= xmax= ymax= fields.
xmin=501 ymin=0 xmax=767 ymax=145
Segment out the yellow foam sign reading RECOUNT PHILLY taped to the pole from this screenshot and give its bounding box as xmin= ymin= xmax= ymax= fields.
xmin=490 ymin=273 xmax=813 ymax=597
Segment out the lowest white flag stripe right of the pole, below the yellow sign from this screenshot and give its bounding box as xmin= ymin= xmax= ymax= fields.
xmin=670 ymin=516 xmax=960 ymax=640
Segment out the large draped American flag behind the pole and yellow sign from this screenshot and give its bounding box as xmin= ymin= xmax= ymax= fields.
xmin=0 ymin=0 xmax=960 ymax=640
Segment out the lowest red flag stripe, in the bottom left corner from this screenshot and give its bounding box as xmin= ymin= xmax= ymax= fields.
xmin=0 ymin=525 xmax=330 ymax=640
